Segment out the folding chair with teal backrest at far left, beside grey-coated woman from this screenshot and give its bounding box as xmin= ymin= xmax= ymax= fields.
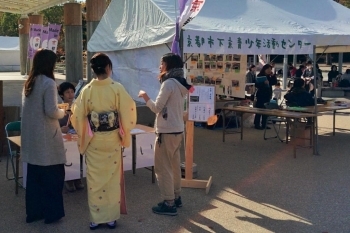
xmin=5 ymin=121 xmax=22 ymax=190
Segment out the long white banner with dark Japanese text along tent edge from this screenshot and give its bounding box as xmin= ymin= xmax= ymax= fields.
xmin=183 ymin=30 xmax=314 ymax=54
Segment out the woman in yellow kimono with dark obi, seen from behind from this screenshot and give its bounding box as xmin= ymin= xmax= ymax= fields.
xmin=71 ymin=53 xmax=136 ymax=230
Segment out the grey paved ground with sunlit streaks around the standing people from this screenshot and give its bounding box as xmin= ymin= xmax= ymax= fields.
xmin=0 ymin=74 xmax=350 ymax=233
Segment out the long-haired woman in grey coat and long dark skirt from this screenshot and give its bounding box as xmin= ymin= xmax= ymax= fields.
xmin=21 ymin=49 xmax=66 ymax=224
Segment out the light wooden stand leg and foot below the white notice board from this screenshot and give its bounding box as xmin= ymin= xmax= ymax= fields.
xmin=181 ymin=121 xmax=212 ymax=194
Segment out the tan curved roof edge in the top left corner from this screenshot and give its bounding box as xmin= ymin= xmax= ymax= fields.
xmin=0 ymin=0 xmax=67 ymax=14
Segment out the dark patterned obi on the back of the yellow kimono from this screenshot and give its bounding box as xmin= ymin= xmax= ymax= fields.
xmin=88 ymin=111 xmax=119 ymax=132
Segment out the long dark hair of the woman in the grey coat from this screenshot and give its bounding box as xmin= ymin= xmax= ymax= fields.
xmin=24 ymin=49 xmax=57 ymax=97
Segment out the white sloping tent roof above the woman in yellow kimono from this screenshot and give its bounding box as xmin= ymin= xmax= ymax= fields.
xmin=88 ymin=0 xmax=177 ymax=52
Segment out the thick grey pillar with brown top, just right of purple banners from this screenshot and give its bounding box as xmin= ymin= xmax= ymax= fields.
xmin=64 ymin=2 xmax=83 ymax=83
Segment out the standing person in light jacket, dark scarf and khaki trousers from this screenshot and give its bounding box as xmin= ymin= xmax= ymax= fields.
xmin=139 ymin=53 xmax=192 ymax=216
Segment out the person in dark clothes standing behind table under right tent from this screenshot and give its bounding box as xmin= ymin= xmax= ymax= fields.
xmin=254 ymin=64 xmax=277 ymax=130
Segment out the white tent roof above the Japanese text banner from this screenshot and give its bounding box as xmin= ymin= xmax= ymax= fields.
xmin=185 ymin=0 xmax=350 ymax=45
